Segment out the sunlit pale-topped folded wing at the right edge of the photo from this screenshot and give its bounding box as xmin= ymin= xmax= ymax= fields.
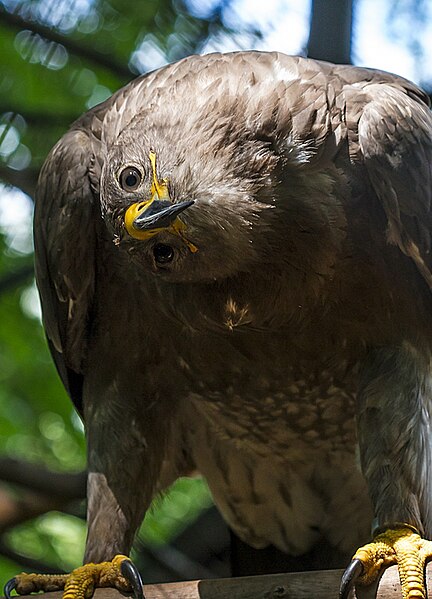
xmin=358 ymin=78 xmax=432 ymax=290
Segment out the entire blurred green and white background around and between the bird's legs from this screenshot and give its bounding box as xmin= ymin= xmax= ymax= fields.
xmin=0 ymin=0 xmax=432 ymax=582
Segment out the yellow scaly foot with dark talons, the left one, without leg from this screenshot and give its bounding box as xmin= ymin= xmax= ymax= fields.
xmin=4 ymin=555 xmax=144 ymax=599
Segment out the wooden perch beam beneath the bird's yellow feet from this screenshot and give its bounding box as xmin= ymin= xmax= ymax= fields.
xmin=9 ymin=563 xmax=432 ymax=599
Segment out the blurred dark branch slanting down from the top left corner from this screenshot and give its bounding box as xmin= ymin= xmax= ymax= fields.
xmin=0 ymin=3 xmax=136 ymax=83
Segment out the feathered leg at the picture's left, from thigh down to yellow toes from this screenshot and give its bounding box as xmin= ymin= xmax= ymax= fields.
xmin=4 ymin=359 xmax=169 ymax=599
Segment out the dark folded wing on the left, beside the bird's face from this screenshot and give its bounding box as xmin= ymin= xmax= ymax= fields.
xmin=34 ymin=130 xmax=100 ymax=410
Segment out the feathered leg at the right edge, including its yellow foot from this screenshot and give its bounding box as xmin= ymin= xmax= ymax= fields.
xmin=340 ymin=344 xmax=432 ymax=599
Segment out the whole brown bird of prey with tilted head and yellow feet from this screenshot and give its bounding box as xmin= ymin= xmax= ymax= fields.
xmin=7 ymin=51 xmax=432 ymax=599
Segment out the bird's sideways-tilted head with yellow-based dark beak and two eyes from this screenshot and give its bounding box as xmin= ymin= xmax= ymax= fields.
xmin=100 ymin=119 xmax=275 ymax=282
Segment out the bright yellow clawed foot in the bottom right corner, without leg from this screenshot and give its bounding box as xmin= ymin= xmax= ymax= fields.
xmin=339 ymin=525 xmax=432 ymax=599
